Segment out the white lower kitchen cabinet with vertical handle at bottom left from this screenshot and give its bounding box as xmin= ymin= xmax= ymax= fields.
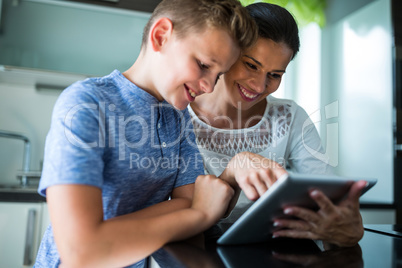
xmin=0 ymin=202 xmax=49 ymax=268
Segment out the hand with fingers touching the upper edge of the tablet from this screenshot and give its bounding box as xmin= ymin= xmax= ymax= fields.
xmin=220 ymin=152 xmax=287 ymax=200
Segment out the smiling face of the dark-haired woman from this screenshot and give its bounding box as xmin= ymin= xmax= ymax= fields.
xmin=217 ymin=38 xmax=293 ymax=110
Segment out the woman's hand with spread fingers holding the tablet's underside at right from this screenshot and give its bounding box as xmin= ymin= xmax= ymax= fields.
xmin=273 ymin=181 xmax=367 ymax=247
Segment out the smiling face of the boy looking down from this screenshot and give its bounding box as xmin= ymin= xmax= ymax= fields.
xmin=155 ymin=28 xmax=240 ymax=110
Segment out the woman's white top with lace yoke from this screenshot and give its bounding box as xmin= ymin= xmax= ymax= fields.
xmin=188 ymin=96 xmax=333 ymax=223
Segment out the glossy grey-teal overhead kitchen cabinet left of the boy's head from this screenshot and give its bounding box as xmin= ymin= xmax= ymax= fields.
xmin=0 ymin=0 xmax=151 ymax=77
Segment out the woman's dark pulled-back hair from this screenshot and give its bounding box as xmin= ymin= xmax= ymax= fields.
xmin=246 ymin=3 xmax=300 ymax=59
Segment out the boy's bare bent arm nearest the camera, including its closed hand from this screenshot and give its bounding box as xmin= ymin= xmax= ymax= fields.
xmin=47 ymin=176 xmax=233 ymax=267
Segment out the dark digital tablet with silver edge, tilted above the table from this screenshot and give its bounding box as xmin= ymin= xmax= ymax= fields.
xmin=217 ymin=174 xmax=377 ymax=245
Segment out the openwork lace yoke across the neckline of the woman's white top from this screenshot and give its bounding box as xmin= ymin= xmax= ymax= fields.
xmin=190 ymin=103 xmax=292 ymax=157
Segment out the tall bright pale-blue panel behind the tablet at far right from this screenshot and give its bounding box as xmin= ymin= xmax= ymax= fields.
xmin=322 ymin=0 xmax=393 ymax=204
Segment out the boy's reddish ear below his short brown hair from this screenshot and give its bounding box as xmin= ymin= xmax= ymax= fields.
xmin=150 ymin=18 xmax=173 ymax=51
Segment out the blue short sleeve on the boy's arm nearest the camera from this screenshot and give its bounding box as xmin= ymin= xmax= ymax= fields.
xmin=38 ymin=83 xmax=104 ymax=196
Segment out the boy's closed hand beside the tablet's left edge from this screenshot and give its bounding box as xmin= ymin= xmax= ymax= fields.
xmin=192 ymin=175 xmax=234 ymax=226
